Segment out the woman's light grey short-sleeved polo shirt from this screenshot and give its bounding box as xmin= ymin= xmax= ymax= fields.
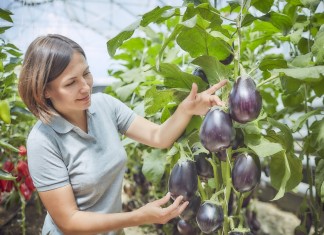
xmin=27 ymin=93 xmax=135 ymax=235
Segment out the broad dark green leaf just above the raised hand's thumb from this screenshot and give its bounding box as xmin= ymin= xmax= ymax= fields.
xmin=157 ymin=63 xmax=206 ymax=91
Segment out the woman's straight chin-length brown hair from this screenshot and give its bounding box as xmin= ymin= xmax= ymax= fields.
xmin=18 ymin=34 xmax=86 ymax=123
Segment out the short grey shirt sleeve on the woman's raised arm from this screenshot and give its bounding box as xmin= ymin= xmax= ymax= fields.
xmin=104 ymin=94 xmax=136 ymax=134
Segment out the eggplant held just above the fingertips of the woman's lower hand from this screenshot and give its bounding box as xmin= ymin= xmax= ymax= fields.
xmin=169 ymin=160 xmax=198 ymax=201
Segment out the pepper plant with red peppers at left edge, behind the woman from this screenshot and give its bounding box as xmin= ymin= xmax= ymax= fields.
xmin=0 ymin=8 xmax=35 ymax=234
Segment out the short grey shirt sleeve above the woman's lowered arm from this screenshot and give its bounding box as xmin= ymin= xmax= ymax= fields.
xmin=27 ymin=123 xmax=69 ymax=192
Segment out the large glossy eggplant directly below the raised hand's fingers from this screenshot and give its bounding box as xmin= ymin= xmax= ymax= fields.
xmin=199 ymin=108 xmax=233 ymax=152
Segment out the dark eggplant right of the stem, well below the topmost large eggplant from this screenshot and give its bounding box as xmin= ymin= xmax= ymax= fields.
xmin=232 ymin=153 xmax=261 ymax=193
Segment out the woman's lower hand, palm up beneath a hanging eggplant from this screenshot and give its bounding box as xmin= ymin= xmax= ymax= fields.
xmin=137 ymin=192 xmax=189 ymax=224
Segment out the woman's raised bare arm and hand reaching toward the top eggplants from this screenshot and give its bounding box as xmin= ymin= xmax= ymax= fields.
xmin=125 ymin=80 xmax=227 ymax=148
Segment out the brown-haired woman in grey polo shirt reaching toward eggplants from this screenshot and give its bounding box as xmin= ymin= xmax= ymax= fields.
xmin=19 ymin=35 xmax=226 ymax=235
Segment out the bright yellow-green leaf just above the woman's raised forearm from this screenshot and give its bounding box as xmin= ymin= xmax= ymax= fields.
xmin=144 ymin=86 xmax=174 ymax=116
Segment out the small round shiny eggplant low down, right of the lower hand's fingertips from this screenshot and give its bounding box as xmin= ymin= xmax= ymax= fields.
xmin=196 ymin=201 xmax=224 ymax=234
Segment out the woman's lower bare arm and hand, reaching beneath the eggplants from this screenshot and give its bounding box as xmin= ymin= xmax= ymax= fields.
xmin=39 ymin=185 xmax=188 ymax=235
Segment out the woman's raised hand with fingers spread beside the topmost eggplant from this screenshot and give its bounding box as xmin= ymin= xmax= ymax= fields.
xmin=181 ymin=80 xmax=227 ymax=115
